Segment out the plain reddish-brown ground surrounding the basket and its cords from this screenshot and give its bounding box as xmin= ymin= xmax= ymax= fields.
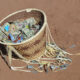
xmin=0 ymin=0 xmax=80 ymax=80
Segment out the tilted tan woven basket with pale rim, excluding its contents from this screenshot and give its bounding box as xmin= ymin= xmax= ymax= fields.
xmin=0 ymin=9 xmax=47 ymax=60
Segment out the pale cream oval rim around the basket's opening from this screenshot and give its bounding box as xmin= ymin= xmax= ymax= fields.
xmin=0 ymin=8 xmax=47 ymax=45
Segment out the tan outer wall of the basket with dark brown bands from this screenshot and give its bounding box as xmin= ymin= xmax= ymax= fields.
xmin=14 ymin=28 xmax=46 ymax=59
